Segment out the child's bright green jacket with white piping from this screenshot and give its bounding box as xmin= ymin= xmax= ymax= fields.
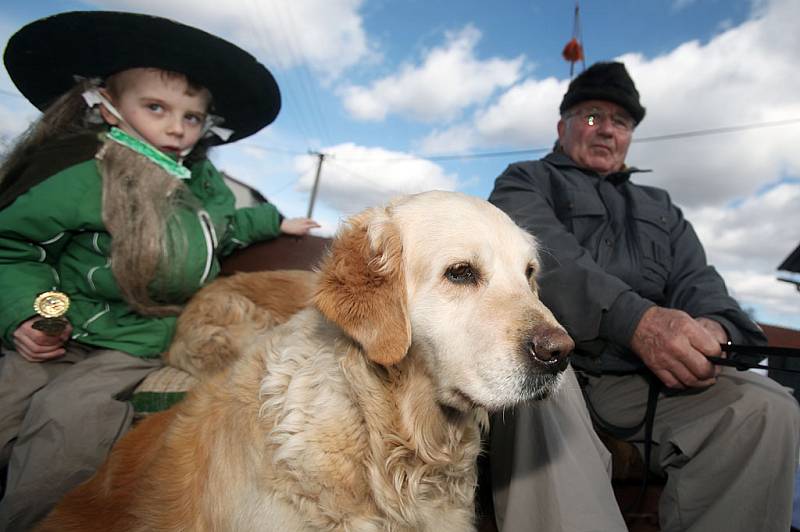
xmin=0 ymin=137 xmax=281 ymax=357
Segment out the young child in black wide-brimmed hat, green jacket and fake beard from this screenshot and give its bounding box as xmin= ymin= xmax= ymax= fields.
xmin=0 ymin=12 xmax=318 ymax=530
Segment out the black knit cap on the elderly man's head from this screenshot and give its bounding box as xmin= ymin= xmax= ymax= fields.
xmin=558 ymin=61 xmax=645 ymax=124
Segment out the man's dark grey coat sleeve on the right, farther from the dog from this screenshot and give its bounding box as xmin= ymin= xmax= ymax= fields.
xmin=666 ymin=206 xmax=766 ymax=345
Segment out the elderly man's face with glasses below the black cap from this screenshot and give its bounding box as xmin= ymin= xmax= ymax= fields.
xmin=558 ymin=100 xmax=635 ymax=175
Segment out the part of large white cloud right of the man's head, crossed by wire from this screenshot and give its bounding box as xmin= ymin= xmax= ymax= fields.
xmin=622 ymin=0 xmax=800 ymax=205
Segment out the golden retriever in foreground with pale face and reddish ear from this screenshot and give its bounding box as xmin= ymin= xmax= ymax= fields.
xmin=40 ymin=192 xmax=573 ymax=532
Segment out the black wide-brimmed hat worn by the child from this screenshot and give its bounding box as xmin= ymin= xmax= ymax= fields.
xmin=3 ymin=11 xmax=281 ymax=142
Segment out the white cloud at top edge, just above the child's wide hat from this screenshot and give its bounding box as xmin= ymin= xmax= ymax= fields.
xmin=93 ymin=0 xmax=372 ymax=77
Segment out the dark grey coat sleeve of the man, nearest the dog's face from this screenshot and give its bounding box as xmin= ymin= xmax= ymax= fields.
xmin=489 ymin=161 xmax=653 ymax=346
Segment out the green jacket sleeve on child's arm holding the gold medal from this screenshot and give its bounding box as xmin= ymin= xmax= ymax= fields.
xmin=0 ymin=168 xmax=85 ymax=347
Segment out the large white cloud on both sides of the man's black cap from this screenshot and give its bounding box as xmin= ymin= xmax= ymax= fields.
xmin=420 ymin=0 xmax=800 ymax=212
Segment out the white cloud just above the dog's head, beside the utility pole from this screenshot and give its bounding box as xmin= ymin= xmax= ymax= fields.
xmin=295 ymin=143 xmax=457 ymax=215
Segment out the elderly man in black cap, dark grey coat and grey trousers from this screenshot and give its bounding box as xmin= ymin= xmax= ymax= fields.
xmin=489 ymin=62 xmax=800 ymax=532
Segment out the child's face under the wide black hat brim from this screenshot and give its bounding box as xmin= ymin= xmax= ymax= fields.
xmin=101 ymin=68 xmax=210 ymax=155
